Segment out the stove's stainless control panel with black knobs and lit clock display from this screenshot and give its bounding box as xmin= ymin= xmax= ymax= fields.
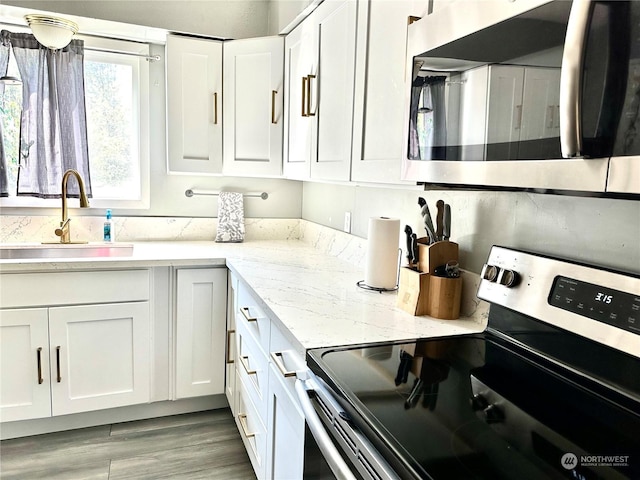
xmin=478 ymin=246 xmax=640 ymax=358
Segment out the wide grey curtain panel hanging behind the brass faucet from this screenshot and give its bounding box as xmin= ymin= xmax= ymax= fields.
xmin=11 ymin=33 xmax=91 ymax=198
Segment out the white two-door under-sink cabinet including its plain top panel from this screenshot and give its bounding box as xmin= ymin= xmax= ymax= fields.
xmin=0 ymin=270 xmax=151 ymax=422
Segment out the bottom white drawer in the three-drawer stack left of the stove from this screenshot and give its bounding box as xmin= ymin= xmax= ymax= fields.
xmin=236 ymin=374 xmax=267 ymax=480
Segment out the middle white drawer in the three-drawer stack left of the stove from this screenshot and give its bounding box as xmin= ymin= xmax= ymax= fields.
xmin=236 ymin=318 xmax=269 ymax=423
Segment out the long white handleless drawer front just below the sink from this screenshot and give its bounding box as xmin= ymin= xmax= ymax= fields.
xmin=0 ymin=270 xmax=151 ymax=308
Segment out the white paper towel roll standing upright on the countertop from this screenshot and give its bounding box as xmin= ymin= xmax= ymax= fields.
xmin=364 ymin=217 xmax=400 ymax=288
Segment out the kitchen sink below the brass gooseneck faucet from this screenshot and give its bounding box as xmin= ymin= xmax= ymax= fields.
xmin=0 ymin=243 xmax=133 ymax=259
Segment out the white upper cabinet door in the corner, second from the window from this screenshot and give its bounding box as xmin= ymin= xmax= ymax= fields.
xmin=223 ymin=37 xmax=284 ymax=176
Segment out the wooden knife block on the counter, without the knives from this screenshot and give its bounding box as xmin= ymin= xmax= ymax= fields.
xmin=396 ymin=239 xmax=462 ymax=320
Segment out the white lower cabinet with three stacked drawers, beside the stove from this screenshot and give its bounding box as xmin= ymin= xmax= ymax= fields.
xmin=226 ymin=274 xmax=305 ymax=480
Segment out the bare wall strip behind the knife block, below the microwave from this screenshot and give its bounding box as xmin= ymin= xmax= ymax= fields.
xmin=302 ymin=183 xmax=640 ymax=273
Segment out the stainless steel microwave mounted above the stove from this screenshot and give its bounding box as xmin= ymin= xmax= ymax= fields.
xmin=402 ymin=0 xmax=640 ymax=194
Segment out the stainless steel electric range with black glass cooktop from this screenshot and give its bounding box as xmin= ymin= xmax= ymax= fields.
xmin=296 ymin=247 xmax=640 ymax=480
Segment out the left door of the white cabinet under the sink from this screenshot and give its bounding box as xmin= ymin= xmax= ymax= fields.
xmin=0 ymin=308 xmax=51 ymax=422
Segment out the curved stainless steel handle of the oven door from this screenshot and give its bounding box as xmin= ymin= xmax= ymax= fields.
xmin=296 ymin=378 xmax=356 ymax=480
